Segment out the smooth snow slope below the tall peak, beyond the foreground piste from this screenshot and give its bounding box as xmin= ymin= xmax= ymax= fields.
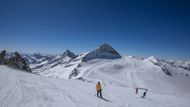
xmin=75 ymin=57 xmax=190 ymax=95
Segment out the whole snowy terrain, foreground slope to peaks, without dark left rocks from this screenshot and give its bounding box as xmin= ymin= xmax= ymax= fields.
xmin=0 ymin=44 xmax=190 ymax=107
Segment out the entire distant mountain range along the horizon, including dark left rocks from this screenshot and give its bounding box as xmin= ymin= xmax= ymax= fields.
xmin=0 ymin=44 xmax=190 ymax=79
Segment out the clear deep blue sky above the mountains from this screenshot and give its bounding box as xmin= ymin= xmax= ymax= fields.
xmin=0 ymin=0 xmax=190 ymax=58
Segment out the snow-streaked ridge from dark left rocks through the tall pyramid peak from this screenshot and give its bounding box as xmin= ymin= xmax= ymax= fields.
xmin=23 ymin=44 xmax=121 ymax=79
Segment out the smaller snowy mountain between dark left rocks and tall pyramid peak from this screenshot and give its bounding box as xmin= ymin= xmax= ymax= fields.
xmin=25 ymin=50 xmax=85 ymax=79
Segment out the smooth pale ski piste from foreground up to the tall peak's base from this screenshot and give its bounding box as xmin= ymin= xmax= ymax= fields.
xmin=0 ymin=57 xmax=190 ymax=107
